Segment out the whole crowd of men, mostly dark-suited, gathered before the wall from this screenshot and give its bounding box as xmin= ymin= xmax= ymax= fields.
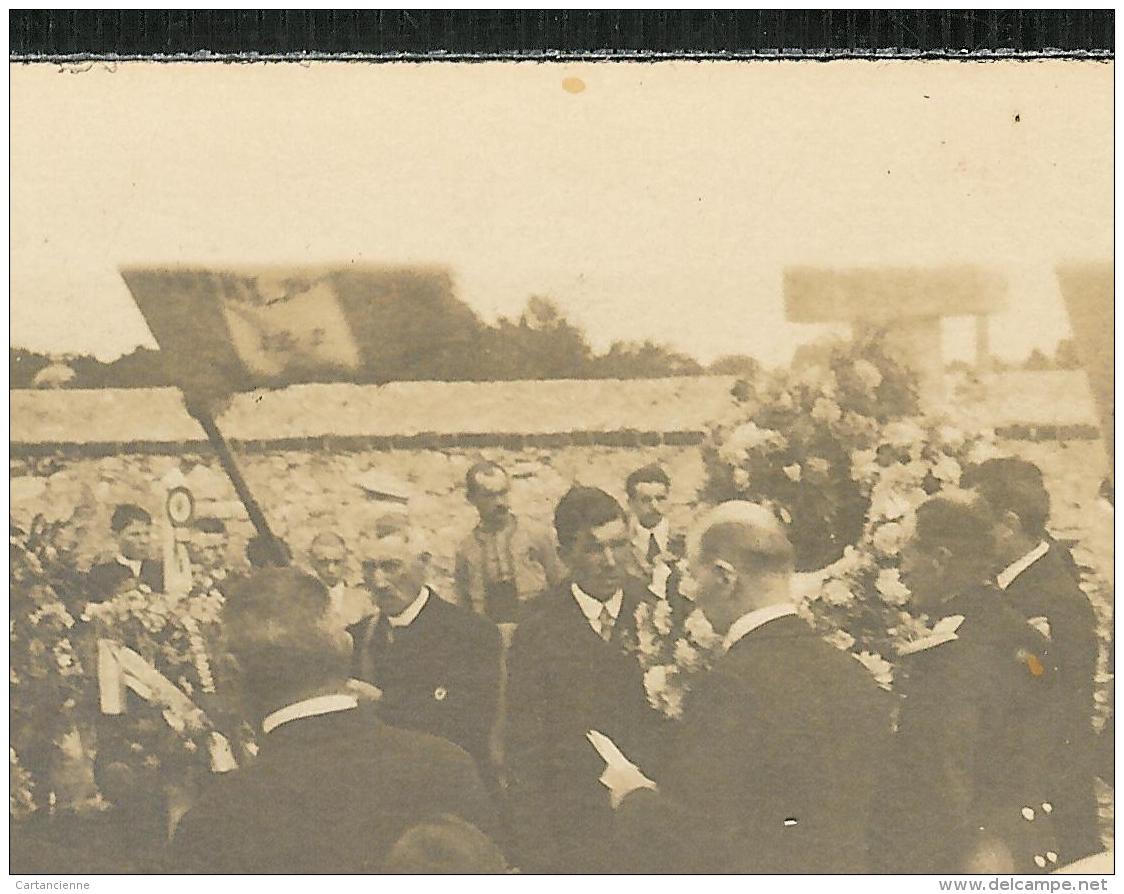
xmin=26 ymin=459 xmax=1100 ymax=873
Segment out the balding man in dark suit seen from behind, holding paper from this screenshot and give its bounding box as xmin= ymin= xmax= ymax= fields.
xmin=605 ymin=502 xmax=889 ymax=873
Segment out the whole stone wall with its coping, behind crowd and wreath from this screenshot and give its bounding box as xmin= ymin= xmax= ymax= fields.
xmin=10 ymin=373 xmax=1112 ymax=587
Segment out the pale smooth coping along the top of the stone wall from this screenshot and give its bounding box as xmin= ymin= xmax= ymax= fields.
xmin=9 ymin=370 xmax=1098 ymax=455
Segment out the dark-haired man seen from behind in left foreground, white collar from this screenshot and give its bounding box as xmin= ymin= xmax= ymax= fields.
xmin=170 ymin=568 xmax=493 ymax=874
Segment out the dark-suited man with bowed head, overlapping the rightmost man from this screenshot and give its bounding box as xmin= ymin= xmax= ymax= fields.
xmin=878 ymin=497 xmax=1067 ymax=874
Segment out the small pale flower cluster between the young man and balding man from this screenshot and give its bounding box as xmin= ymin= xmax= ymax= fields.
xmin=626 ymin=599 xmax=722 ymax=720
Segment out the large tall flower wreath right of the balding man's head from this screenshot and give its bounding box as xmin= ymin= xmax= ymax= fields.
xmin=704 ymin=334 xmax=998 ymax=688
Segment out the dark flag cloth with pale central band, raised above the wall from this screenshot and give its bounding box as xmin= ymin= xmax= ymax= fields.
xmin=121 ymin=267 xmax=478 ymax=401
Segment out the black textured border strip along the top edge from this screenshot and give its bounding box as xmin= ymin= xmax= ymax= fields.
xmin=9 ymin=9 xmax=1114 ymax=62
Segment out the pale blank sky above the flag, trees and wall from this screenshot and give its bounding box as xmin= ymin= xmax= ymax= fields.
xmin=11 ymin=61 xmax=1113 ymax=362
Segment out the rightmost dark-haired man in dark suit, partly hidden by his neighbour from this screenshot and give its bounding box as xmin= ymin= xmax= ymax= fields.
xmin=962 ymin=458 xmax=1102 ymax=861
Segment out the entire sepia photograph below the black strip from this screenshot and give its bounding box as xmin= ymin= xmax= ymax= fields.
xmin=9 ymin=50 xmax=1115 ymax=891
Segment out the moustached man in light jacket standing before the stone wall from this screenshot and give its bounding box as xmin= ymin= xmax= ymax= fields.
xmin=454 ymin=462 xmax=563 ymax=625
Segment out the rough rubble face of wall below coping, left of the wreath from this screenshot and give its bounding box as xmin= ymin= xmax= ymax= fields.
xmin=10 ymin=444 xmax=703 ymax=590
